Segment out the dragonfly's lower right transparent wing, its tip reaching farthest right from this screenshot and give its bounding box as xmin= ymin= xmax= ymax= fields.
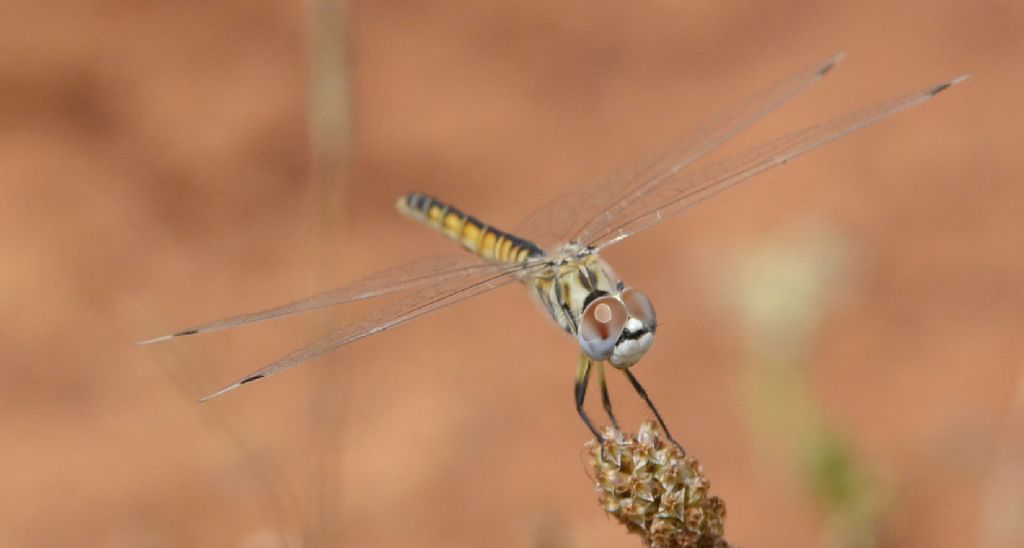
xmin=581 ymin=75 xmax=967 ymax=249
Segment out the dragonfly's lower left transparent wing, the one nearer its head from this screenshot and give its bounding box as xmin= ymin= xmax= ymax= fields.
xmin=201 ymin=262 xmax=545 ymax=402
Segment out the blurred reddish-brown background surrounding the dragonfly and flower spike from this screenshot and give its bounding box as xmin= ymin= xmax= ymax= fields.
xmin=0 ymin=0 xmax=1024 ymax=547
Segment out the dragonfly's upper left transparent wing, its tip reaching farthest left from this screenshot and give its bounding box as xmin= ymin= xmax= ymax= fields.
xmin=138 ymin=254 xmax=509 ymax=344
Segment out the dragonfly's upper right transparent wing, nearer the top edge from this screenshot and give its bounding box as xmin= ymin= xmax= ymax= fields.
xmin=516 ymin=52 xmax=844 ymax=248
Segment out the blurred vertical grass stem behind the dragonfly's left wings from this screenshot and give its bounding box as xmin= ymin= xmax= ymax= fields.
xmin=303 ymin=0 xmax=352 ymax=546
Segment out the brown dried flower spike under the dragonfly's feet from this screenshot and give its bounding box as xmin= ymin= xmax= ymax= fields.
xmin=587 ymin=421 xmax=729 ymax=548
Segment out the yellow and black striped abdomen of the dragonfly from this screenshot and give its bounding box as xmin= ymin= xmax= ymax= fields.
xmin=395 ymin=193 xmax=544 ymax=263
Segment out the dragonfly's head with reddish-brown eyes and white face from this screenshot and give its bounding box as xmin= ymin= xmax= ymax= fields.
xmin=577 ymin=288 xmax=657 ymax=369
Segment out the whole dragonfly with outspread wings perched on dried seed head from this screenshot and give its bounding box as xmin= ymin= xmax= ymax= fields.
xmin=138 ymin=52 xmax=967 ymax=454
